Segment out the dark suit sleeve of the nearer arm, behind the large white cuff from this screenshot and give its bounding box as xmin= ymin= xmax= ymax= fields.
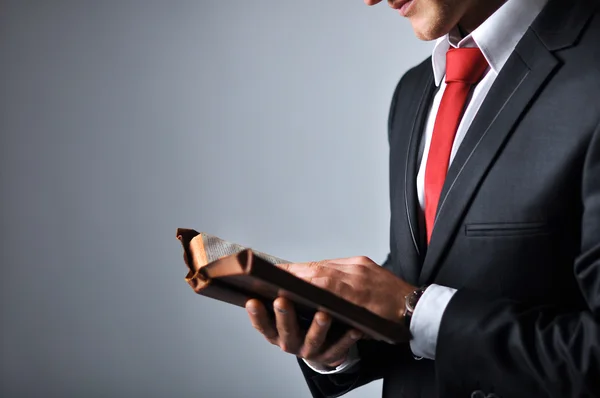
xmin=436 ymin=126 xmax=600 ymax=397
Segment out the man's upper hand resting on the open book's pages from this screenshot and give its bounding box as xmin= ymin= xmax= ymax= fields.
xmin=278 ymin=257 xmax=416 ymax=322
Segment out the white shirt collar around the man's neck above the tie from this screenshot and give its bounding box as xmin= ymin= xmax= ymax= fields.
xmin=431 ymin=0 xmax=548 ymax=86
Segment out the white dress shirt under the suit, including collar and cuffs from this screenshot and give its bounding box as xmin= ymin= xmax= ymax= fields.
xmin=309 ymin=0 xmax=548 ymax=373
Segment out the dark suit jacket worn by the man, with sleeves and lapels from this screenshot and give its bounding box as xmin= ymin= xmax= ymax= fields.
xmin=301 ymin=0 xmax=600 ymax=398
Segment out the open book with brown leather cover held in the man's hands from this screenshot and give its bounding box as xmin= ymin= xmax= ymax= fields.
xmin=177 ymin=228 xmax=409 ymax=344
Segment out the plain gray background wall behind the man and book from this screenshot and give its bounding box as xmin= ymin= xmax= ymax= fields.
xmin=0 ymin=0 xmax=431 ymax=398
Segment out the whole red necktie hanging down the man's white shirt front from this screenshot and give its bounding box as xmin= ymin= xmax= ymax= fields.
xmin=425 ymin=48 xmax=488 ymax=243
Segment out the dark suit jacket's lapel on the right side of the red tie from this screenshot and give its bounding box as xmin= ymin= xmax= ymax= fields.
xmin=419 ymin=0 xmax=591 ymax=284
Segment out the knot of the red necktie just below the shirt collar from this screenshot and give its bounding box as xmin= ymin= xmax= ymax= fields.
xmin=446 ymin=48 xmax=488 ymax=84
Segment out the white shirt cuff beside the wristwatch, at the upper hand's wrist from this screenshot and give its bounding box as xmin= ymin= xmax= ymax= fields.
xmin=410 ymin=285 xmax=456 ymax=359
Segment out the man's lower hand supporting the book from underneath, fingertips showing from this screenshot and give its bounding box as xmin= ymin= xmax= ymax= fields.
xmin=246 ymin=297 xmax=362 ymax=368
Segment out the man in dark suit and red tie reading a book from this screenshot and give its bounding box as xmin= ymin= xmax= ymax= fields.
xmin=247 ymin=0 xmax=600 ymax=398
